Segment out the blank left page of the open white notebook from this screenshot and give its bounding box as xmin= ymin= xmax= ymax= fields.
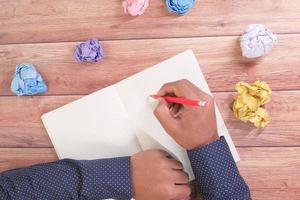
xmin=42 ymin=87 xmax=141 ymax=159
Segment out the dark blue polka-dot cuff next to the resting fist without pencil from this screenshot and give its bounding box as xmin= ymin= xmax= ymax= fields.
xmin=74 ymin=157 xmax=133 ymax=200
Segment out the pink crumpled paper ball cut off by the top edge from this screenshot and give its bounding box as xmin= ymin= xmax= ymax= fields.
xmin=122 ymin=0 xmax=149 ymax=16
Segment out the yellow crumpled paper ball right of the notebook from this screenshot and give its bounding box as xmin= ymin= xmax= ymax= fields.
xmin=232 ymin=81 xmax=272 ymax=128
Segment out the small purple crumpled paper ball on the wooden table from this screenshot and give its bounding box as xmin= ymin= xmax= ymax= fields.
xmin=74 ymin=38 xmax=104 ymax=62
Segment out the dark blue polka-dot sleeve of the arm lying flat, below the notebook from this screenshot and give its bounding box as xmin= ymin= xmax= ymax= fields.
xmin=0 ymin=157 xmax=132 ymax=200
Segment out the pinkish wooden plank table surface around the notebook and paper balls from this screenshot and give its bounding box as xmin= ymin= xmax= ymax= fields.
xmin=0 ymin=0 xmax=300 ymax=200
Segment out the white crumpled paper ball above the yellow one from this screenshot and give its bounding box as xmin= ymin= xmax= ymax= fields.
xmin=240 ymin=24 xmax=277 ymax=58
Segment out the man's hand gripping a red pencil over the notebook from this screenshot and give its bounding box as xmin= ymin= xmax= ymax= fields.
xmin=154 ymin=80 xmax=218 ymax=150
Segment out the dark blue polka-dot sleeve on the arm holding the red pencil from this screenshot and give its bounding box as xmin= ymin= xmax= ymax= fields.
xmin=188 ymin=137 xmax=251 ymax=200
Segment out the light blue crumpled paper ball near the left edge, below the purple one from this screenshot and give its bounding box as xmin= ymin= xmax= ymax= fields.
xmin=11 ymin=63 xmax=48 ymax=96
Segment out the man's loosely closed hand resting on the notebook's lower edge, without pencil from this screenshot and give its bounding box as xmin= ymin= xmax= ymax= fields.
xmin=131 ymin=150 xmax=191 ymax=200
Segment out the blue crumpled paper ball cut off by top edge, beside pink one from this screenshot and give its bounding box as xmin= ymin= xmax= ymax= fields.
xmin=166 ymin=0 xmax=196 ymax=15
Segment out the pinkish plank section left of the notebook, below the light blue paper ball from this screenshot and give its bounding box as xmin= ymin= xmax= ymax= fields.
xmin=0 ymin=96 xmax=81 ymax=147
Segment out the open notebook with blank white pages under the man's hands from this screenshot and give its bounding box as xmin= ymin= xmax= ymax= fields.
xmin=42 ymin=50 xmax=239 ymax=180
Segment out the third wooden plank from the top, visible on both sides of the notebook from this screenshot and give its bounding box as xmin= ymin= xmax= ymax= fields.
xmin=0 ymin=91 xmax=300 ymax=147
